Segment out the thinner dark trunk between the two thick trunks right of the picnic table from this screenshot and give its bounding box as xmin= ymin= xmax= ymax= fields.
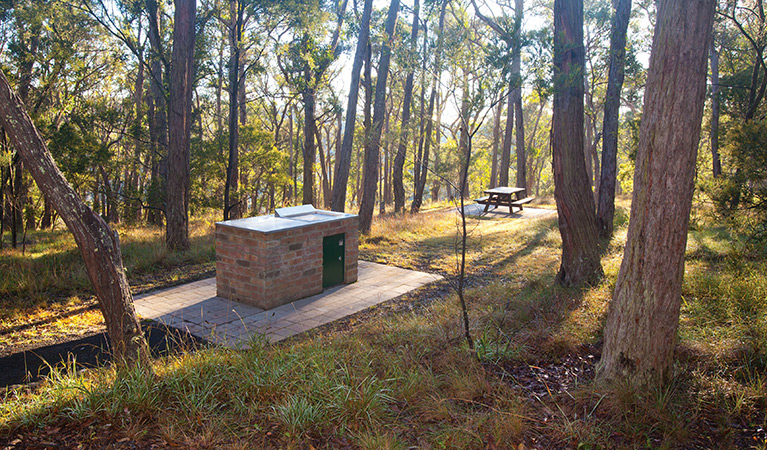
xmin=597 ymin=0 xmax=631 ymax=239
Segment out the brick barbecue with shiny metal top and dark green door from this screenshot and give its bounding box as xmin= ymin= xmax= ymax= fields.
xmin=216 ymin=205 xmax=359 ymax=309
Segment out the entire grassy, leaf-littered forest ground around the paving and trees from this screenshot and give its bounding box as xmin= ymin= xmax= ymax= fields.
xmin=0 ymin=202 xmax=767 ymax=449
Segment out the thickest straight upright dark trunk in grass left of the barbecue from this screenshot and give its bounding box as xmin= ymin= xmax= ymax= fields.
xmin=165 ymin=0 xmax=196 ymax=251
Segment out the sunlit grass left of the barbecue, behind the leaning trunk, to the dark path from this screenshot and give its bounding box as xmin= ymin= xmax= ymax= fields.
xmin=0 ymin=218 xmax=215 ymax=349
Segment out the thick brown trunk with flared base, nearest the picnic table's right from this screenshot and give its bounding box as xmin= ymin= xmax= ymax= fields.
xmin=552 ymin=0 xmax=602 ymax=286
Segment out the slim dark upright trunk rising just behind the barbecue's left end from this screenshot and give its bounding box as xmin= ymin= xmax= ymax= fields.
xmin=224 ymin=0 xmax=245 ymax=220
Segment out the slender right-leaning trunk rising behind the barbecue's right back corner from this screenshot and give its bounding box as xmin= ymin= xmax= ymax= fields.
xmin=331 ymin=0 xmax=373 ymax=212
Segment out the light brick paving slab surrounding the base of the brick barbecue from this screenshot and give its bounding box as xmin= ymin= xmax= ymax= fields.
xmin=134 ymin=261 xmax=442 ymax=348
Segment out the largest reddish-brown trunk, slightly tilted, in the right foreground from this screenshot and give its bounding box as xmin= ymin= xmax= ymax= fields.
xmin=598 ymin=0 xmax=716 ymax=385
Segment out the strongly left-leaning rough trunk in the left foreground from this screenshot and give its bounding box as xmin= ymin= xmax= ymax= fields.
xmin=0 ymin=67 xmax=149 ymax=367
